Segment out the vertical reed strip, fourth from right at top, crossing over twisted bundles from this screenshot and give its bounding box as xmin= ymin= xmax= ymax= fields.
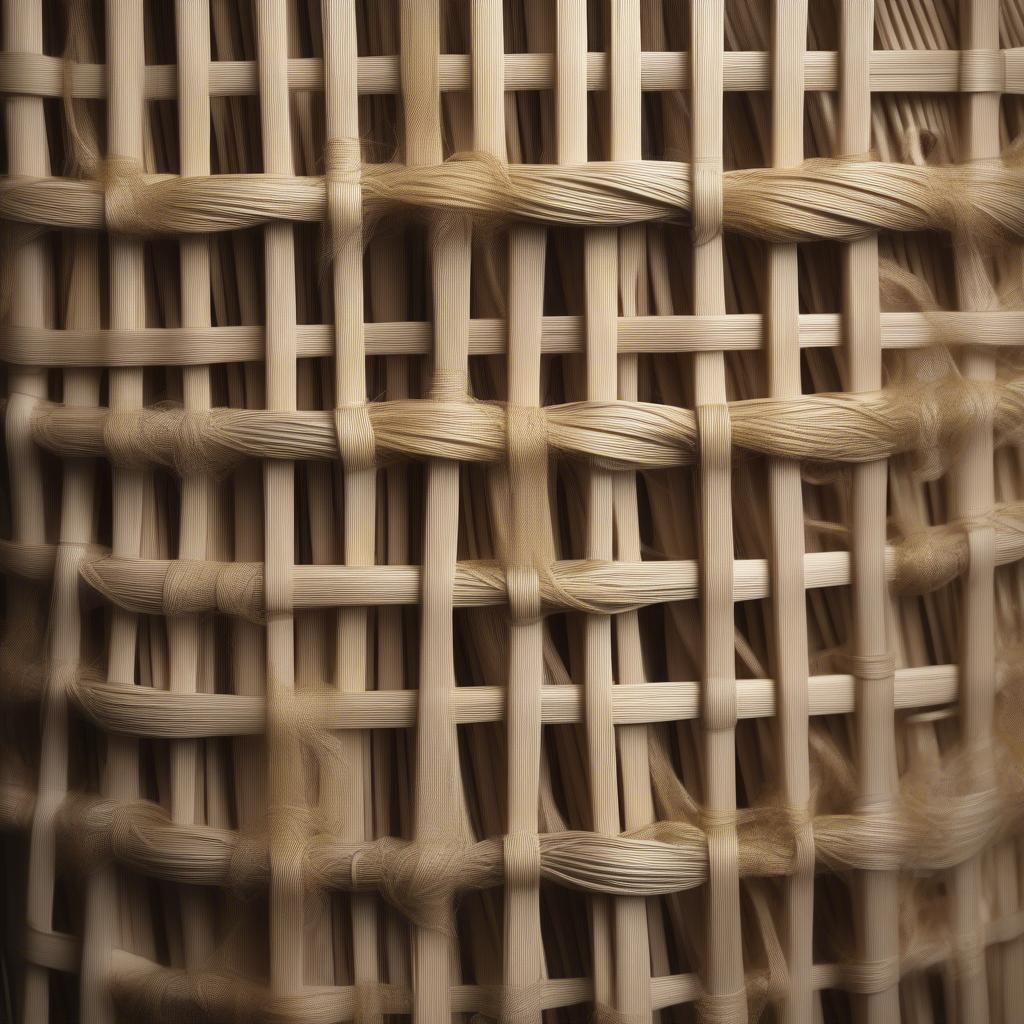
xmin=690 ymin=0 xmax=746 ymax=1019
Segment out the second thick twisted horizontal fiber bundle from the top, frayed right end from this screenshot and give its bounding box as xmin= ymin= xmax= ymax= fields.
xmin=25 ymin=370 xmax=1024 ymax=474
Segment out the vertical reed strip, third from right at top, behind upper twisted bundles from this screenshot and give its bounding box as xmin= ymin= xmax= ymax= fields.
xmin=766 ymin=0 xmax=814 ymax=1024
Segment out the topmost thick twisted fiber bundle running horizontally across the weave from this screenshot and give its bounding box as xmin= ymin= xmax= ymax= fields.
xmin=6 ymin=151 xmax=1024 ymax=242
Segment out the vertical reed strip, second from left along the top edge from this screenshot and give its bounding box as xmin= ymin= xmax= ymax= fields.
xmin=81 ymin=0 xmax=147 ymax=1022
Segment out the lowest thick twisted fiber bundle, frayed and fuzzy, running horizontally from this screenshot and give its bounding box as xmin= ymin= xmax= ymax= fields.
xmin=3 ymin=658 xmax=1024 ymax=913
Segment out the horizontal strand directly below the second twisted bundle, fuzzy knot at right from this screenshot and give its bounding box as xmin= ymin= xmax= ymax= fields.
xmin=8 ymin=502 xmax=1024 ymax=618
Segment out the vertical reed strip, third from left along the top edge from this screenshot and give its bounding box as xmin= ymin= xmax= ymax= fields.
xmin=167 ymin=0 xmax=213 ymax=967
